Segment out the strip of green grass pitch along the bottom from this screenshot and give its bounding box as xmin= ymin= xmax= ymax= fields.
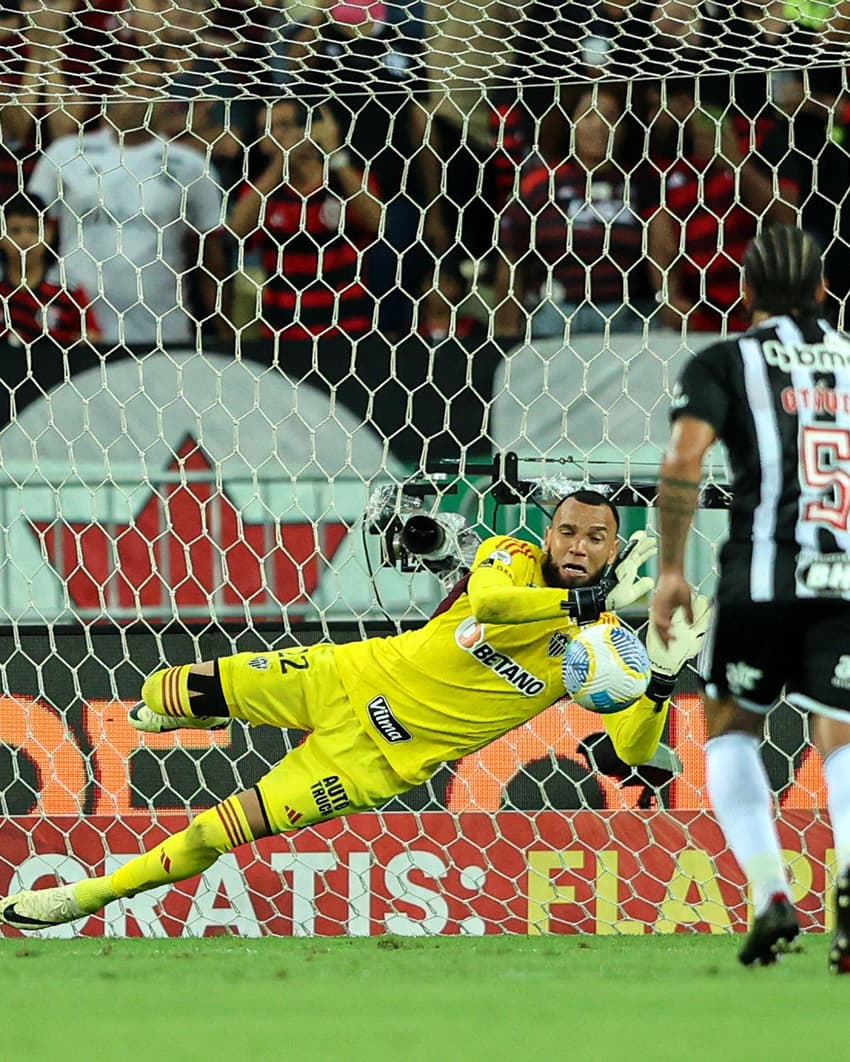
xmin=0 ymin=936 xmax=850 ymax=1062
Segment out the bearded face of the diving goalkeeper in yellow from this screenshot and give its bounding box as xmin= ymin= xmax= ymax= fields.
xmin=543 ymin=498 xmax=617 ymax=589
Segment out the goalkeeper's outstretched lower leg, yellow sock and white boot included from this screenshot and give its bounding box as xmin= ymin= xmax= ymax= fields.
xmin=0 ymin=789 xmax=272 ymax=930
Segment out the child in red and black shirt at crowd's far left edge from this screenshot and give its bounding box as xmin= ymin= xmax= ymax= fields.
xmin=0 ymin=194 xmax=99 ymax=348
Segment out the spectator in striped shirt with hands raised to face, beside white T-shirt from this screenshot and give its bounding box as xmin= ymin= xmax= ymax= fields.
xmin=230 ymin=100 xmax=381 ymax=339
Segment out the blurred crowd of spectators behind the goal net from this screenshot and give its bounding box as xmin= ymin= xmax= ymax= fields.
xmin=0 ymin=0 xmax=850 ymax=347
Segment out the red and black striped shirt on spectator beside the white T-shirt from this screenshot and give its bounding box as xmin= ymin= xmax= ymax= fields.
xmin=247 ymin=174 xmax=374 ymax=339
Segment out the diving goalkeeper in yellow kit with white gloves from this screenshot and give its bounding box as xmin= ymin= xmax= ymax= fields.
xmin=0 ymin=491 xmax=708 ymax=929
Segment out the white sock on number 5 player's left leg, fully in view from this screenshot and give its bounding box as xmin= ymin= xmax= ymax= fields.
xmin=706 ymin=733 xmax=786 ymax=914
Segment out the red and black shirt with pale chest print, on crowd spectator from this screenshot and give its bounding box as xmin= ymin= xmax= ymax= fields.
xmin=502 ymin=161 xmax=643 ymax=304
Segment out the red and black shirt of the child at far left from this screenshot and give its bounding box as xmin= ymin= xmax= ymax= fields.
xmin=0 ymin=278 xmax=99 ymax=346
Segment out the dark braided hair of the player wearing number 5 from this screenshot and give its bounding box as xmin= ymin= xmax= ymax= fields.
xmin=744 ymin=225 xmax=823 ymax=318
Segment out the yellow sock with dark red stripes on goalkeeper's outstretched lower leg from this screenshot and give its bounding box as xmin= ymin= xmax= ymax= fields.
xmin=73 ymin=797 xmax=254 ymax=913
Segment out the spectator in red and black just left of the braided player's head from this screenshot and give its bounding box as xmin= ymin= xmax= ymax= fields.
xmin=645 ymin=83 xmax=798 ymax=331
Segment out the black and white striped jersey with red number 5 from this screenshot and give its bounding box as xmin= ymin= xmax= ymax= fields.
xmin=670 ymin=316 xmax=850 ymax=604
